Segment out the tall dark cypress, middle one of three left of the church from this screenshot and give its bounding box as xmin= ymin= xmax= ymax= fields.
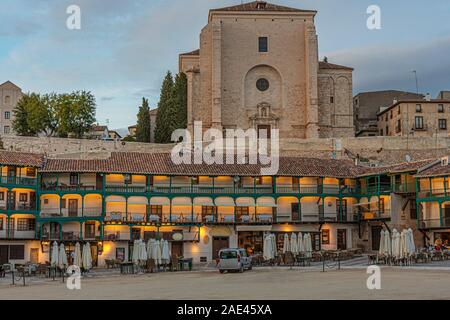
xmin=155 ymin=71 xmax=176 ymax=143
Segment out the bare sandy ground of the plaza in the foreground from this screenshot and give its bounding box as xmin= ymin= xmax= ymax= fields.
xmin=0 ymin=267 xmax=450 ymax=300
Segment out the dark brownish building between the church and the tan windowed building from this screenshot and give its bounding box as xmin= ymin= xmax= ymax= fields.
xmin=353 ymin=90 xmax=423 ymax=137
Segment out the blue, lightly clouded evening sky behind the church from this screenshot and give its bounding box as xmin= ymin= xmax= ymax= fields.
xmin=0 ymin=0 xmax=450 ymax=129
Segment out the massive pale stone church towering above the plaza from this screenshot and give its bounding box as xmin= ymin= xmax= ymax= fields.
xmin=179 ymin=1 xmax=354 ymax=139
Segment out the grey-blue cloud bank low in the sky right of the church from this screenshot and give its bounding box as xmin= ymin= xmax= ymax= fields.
xmin=325 ymin=37 xmax=450 ymax=95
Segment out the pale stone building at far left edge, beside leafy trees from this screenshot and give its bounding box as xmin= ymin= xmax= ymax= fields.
xmin=0 ymin=81 xmax=22 ymax=135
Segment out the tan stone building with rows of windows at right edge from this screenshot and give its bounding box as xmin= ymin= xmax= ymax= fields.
xmin=378 ymin=100 xmax=450 ymax=137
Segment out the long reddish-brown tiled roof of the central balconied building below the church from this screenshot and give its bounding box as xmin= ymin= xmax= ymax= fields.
xmin=42 ymin=152 xmax=357 ymax=178
